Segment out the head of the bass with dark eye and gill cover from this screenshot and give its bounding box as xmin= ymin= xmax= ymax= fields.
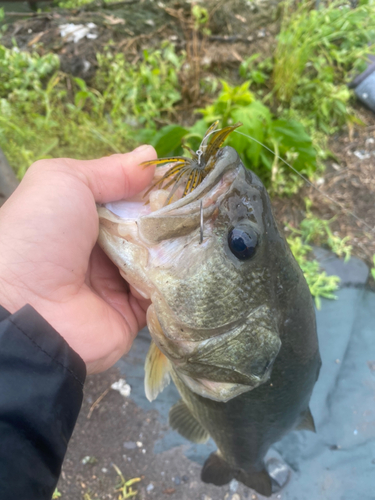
xmin=98 ymin=146 xmax=290 ymax=401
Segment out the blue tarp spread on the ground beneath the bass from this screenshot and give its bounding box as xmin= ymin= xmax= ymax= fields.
xmin=119 ymin=254 xmax=375 ymax=500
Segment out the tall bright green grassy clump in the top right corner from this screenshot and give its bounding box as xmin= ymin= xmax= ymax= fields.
xmin=273 ymin=0 xmax=375 ymax=133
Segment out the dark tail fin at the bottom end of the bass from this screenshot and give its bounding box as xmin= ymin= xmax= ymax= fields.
xmin=201 ymin=451 xmax=272 ymax=497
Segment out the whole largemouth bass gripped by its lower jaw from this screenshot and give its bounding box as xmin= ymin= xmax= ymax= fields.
xmin=98 ymin=124 xmax=321 ymax=496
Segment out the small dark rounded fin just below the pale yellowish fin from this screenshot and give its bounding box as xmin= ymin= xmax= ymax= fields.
xmin=169 ymin=400 xmax=210 ymax=443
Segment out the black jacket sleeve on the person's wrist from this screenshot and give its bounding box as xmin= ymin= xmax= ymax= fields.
xmin=0 ymin=305 xmax=86 ymax=500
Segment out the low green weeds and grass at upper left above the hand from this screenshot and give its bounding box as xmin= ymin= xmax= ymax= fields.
xmin=0 ymin=45 xmax=183 ymax=177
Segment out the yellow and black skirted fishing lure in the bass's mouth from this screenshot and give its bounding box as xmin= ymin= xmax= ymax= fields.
xmin=141 ymin=120 xmax=242 ymax=205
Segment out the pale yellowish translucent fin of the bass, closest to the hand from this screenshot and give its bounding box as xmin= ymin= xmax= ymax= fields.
xmin=145 ymin=342 xmax=171 ymax=401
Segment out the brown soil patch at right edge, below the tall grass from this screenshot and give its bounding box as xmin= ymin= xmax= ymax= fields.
xmin=273 ymin=104 xmax=375 ymax=268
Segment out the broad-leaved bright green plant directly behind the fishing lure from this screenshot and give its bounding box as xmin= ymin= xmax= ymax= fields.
xmin=150 ymin=80 xmax=316 ymax=193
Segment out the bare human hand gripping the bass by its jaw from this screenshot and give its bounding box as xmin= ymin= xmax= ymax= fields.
xmin=0 ymin=146 xmax=156 ymax=373
